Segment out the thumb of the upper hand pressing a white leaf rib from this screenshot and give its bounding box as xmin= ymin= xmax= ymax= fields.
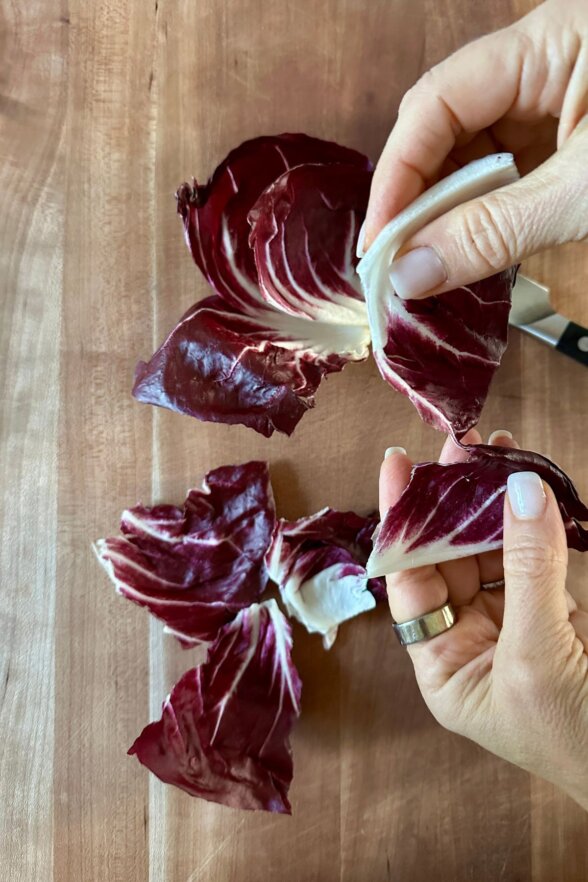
xmin=390 ymin=123 xmax=588 ymax=299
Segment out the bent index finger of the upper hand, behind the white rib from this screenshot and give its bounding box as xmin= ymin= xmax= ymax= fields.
xmin=364 ymin=27 xmax=524 ymax=249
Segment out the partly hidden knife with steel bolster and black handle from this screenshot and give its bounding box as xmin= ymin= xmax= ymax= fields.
xmin=508 ymin=275 xmax=588 ymax=367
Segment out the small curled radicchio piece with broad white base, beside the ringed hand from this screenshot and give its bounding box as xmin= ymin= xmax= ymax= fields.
xmin=266 ymin=508 xmax=386 ymax=649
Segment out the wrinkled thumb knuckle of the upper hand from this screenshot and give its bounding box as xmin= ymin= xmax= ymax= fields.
xmin=460 ymin=198 xmax=520 ymax=272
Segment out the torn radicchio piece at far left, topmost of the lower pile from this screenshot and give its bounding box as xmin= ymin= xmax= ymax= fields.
xmin=95 ymin=461 xmax=275 ymax=645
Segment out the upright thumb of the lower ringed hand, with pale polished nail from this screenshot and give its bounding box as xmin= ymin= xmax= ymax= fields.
xmin=500 ymin=472 xmax=568 ymax=658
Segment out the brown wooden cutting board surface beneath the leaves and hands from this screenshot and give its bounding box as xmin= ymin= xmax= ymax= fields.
xmin=0 ymin=0 xmax=588 ymax=882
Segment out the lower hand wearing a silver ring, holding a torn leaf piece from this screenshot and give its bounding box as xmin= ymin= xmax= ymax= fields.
xmin=380 ymin=430 xmax=588 ymax=809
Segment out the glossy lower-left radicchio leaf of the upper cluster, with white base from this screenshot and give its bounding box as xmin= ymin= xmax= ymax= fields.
xmin=133 ymin=297 xmax=369 ymax=437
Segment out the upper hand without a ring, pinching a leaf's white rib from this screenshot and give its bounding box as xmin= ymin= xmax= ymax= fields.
xmin=364 ymin=0 xmax=588 ymax=298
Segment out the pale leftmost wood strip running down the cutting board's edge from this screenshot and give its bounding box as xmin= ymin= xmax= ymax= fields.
xmin=0 ymin=0 xmax=67 ymax=880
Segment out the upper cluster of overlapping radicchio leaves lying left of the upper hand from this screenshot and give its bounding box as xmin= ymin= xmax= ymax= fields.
xmin=133 ymin=134 xmax=371 ymax=436
